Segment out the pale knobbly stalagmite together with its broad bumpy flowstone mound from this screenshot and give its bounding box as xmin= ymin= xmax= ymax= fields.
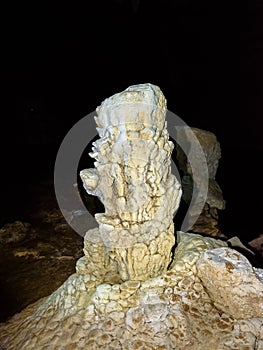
xmin=0 ymin=84 xmax=263 ymax=350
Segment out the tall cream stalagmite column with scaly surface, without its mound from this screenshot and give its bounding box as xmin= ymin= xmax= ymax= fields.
xmin=80 ymin=84 xmax=181 ymax=280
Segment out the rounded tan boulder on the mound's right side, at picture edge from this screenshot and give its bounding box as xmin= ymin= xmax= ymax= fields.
xmin=196 ymin=248 xmax=263 ymax=319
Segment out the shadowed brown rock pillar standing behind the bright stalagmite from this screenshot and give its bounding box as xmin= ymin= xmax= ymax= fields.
xmin=176 ymin=128 xmax=225 ymax=237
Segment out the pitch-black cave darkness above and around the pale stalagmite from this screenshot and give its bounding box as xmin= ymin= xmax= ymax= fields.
xmin=0 ymin=0 xmax=263 ymax=240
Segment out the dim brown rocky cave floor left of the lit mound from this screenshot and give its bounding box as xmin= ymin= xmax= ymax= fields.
xmin=0 ymin=181 xmax=263 ymax=322
